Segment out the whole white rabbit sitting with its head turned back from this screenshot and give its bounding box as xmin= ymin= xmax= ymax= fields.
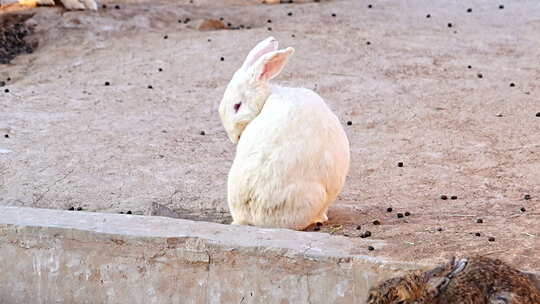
xmin=219 ymin=37 xmax=349 ymax=230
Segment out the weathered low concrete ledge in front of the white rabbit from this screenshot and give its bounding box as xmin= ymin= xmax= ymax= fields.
xmin=0 ymin=207 xmax=536 ymax=303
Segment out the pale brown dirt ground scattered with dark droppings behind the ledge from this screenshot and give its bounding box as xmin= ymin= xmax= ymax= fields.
xmin=0 ymin=0 xmax=540 ymax=270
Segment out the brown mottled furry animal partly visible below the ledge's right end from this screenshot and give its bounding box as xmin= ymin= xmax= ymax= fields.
xmin=367 ymin=256 xmax=540 ymax=304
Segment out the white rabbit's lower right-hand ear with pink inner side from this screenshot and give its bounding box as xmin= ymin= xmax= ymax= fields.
xmin=253 ymin=47 xmax=294 ymax=82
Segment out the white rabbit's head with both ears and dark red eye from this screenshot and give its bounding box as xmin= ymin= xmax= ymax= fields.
xmin=219 ymin=37 xmax=294 ymax=143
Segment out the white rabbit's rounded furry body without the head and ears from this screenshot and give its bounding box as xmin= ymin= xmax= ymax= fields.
xmin=229 ymin=87 xmax=349 ymax=229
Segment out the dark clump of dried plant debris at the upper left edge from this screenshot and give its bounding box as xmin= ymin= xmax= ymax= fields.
xmin=0 ymin=13 xmax=37 ymax=64
